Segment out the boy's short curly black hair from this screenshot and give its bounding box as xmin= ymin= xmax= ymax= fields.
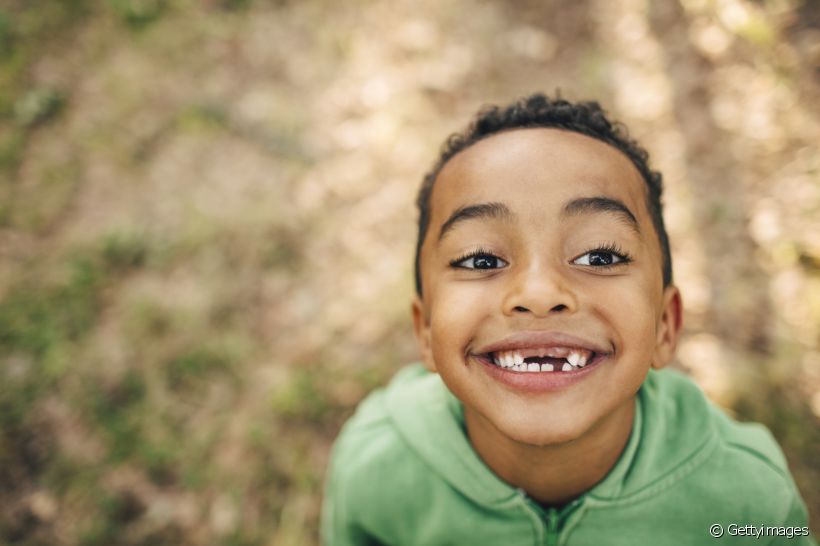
xmin=415 ymin=93 xmax=672 ymax=297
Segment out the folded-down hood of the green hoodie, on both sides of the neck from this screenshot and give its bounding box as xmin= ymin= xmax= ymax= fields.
xmin=386 ymin=365 xmax=716 ymax=507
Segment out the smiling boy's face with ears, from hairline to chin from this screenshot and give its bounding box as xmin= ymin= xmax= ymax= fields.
xmin=413 ymin=129 xmax=681 ymax=445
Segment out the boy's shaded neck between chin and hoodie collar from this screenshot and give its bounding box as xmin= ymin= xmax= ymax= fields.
xmin=464 ymin=400 xmax=635 ymax=506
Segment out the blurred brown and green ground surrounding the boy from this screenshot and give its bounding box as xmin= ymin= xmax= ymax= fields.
xmin=0 ymin=0 xmax=820 ymax=546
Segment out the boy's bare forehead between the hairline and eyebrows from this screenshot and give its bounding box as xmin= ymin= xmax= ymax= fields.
xmin=430 ymin=128 xmax=646 ymax=223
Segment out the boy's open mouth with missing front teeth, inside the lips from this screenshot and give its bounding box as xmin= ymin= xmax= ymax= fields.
xmin=479 ymin=347 xmax=602 ymax=372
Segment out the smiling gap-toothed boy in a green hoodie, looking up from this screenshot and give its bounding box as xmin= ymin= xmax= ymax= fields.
xmin=322 ymin=95 xmax=814 ymax=546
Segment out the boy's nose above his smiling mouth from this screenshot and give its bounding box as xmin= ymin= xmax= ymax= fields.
xmin=503 ymin=263 xmax=578 ymax=316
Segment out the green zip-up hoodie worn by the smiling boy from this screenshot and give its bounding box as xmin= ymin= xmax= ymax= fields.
xmin=322 ymin=365 xmax=815 ymax=546
